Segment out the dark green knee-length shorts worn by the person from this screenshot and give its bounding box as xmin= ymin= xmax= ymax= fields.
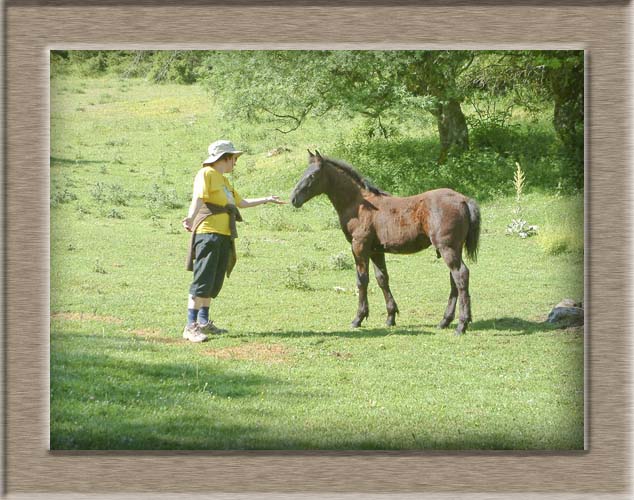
xmin=189 ymin=233 xmax=231 ymax=298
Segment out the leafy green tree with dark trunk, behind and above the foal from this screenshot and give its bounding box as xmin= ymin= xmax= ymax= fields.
xmin=200 ymin=51 xmax=475 ymax=159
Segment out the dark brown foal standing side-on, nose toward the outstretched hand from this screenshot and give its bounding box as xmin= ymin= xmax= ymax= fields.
xmin=291 ymin=151 xmax=480 ymax=335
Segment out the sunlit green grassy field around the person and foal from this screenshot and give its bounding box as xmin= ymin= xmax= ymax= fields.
xmin=50 ymin=77 xmax=583 ymax=449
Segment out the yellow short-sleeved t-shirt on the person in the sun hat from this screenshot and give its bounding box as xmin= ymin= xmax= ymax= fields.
xmin=194 ymin=166 xmax=242 ymax=235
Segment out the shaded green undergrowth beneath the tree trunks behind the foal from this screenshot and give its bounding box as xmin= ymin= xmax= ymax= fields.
xmin=331 ymin=113 xmax=583 ymax=201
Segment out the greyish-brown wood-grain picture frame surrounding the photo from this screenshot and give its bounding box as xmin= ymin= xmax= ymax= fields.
xmin=3 ymin=0 xmax=632 ymax=498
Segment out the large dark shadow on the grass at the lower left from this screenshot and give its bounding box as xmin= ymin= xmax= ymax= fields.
xmin=50 ymin=332 xmax=290 ymax=450
